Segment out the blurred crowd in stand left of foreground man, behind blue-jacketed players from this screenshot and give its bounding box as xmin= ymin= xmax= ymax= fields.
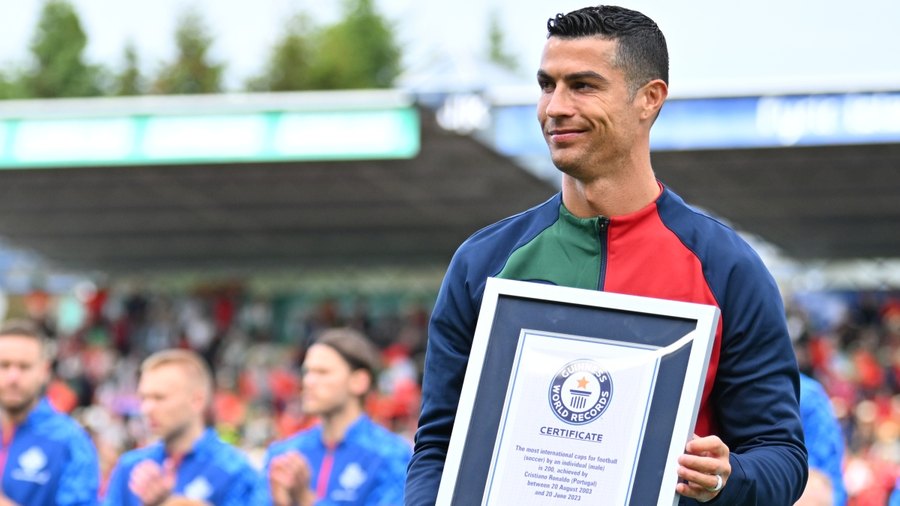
xmin=10 ymin=287 xmax=429 ymax=488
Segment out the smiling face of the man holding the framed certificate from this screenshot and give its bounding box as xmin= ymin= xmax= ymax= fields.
xmin=537 ymin=37 xmax=642 ymax=180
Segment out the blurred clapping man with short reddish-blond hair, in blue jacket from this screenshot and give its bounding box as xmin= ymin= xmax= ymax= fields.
xmin=104 ymin=349 xmax=263 ymax=506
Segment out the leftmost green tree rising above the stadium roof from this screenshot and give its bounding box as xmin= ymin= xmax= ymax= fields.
xmin=23 ymin=0 xmax=103 ymax=98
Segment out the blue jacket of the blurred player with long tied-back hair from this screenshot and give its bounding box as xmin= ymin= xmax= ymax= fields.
xmin=258 ymin=415 xmax=412 ymax=506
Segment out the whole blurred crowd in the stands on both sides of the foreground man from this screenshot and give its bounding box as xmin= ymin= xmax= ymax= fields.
xmin=1 ymin=287 xmax=900 ymax=506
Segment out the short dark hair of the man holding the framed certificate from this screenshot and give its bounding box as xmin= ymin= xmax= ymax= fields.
xmin=547 ymin=5 xmax=669 ymax=96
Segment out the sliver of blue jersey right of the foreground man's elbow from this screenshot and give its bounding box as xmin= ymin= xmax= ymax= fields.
xmin=800 ymin=374 xmax=847 ymax=506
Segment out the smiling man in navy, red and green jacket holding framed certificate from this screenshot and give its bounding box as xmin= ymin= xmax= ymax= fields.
xmin=406 ymin=6 xmax=807 ymax=506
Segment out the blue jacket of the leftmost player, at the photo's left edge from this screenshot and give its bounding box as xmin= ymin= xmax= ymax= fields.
xmin=0 ymin=398 xmax=100 ymax=506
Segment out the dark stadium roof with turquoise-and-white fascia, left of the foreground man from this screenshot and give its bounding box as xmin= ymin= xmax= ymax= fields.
xmin=0 ymin=92 xmax=554 ymax=274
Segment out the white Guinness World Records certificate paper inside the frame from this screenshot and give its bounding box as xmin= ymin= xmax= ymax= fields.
xmin=483 ymin=330 xmax=659 ymax=505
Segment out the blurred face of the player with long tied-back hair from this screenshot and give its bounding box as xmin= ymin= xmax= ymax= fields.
xmin=303 ymin=344 xmax=365 ymax=416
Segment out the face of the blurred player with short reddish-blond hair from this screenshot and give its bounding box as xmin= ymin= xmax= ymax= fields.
xmin=138 ymin=364 xmax=204 ymax=441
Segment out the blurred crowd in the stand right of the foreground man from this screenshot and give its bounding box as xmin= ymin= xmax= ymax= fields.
xmin=788 ymin=292 xmax=900 ymax=506
